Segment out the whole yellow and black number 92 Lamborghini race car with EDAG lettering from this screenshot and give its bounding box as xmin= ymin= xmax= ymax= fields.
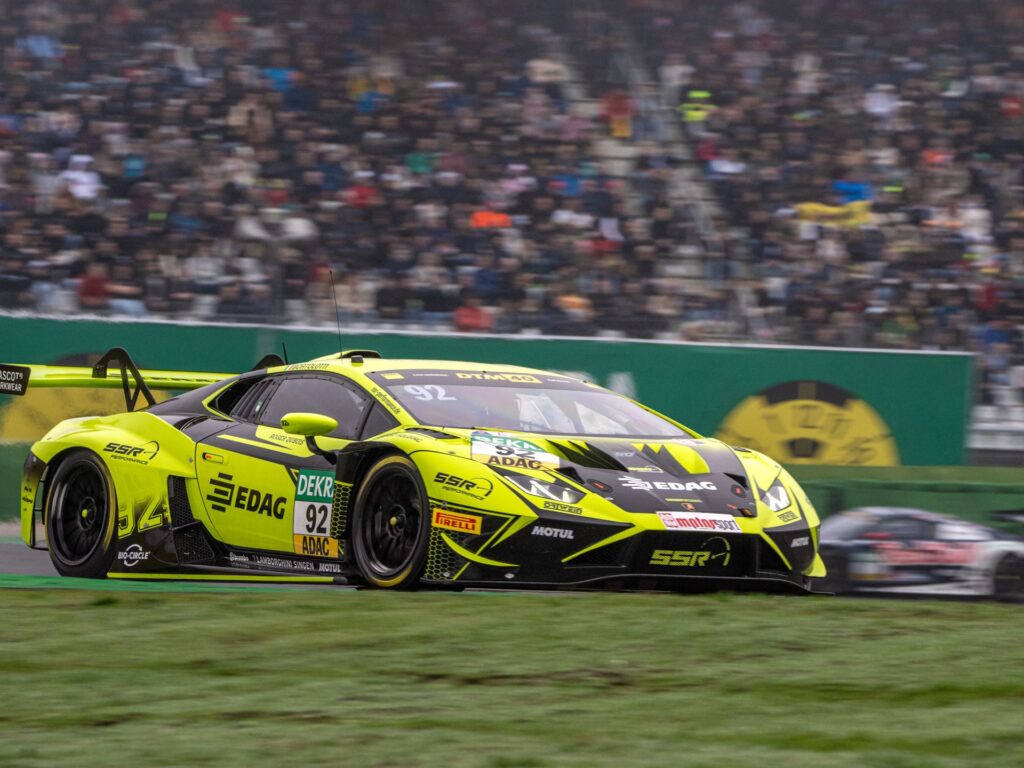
xmin=6 ymin=349 xmax=825 ymax=592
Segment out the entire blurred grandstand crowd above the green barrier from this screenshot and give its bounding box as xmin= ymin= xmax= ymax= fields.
xmin=0 ymin=0 xmax=1024 ymax=397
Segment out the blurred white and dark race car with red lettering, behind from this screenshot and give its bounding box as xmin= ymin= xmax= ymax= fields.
xmin=819 ymin=507 xmax=1024 ymax=601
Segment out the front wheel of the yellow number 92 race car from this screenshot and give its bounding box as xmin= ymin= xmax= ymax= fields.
xmin=351 ymin=456 xmax=430 ymax=590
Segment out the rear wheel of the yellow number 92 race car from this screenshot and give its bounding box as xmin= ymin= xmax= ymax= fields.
xmin=46 ymin=449 xmax=118 ymax=579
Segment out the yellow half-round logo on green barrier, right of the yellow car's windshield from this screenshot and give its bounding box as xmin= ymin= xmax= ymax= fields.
xmin=715 ymin=381 xmax=899 ymax=467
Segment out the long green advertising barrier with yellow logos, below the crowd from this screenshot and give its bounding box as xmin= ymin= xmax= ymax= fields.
xmin=0 ymin=316 xmax=973 ymax=466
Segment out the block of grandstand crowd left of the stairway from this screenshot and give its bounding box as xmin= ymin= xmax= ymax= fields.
xmin=0 ymin=0 xmax=681 ymax=335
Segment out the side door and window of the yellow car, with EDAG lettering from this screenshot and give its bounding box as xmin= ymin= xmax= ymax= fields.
xmin=196 ymin=372 xmax=374 ymax=558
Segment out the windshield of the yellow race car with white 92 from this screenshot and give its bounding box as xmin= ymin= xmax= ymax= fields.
xmin=375 ymin=372 xmax=691 ymax=437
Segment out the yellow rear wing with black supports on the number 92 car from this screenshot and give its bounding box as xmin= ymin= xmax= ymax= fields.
xmin=0 ymin=347 xmax=233 ymax=411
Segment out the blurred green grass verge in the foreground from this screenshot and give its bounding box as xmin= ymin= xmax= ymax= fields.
xmin=0 ymin=590 xmax=1024 ymax=768
